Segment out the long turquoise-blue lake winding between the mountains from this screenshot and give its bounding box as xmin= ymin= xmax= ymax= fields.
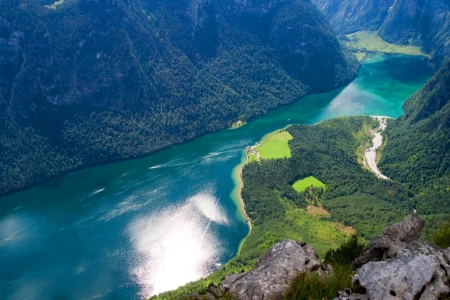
xmin=0 ymin=54 xmax=434 ymax=299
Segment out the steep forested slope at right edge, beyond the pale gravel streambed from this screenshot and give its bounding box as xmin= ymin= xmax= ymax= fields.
xmin=380 ymin=61 xmax=450 ymax=233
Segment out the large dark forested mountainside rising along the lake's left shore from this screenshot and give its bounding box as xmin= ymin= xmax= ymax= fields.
xmin=0 ymin=0 xmax=358 ymax=195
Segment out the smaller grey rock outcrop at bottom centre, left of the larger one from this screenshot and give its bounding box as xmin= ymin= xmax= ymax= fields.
xmin=207 ymin=240 xmax=331 ymax=300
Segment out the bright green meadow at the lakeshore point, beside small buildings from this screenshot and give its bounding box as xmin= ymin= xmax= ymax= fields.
xmin=257 ymin=130 xmax=292 ymax=159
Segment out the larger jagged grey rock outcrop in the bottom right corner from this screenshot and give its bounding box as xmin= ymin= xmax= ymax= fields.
xmin=336 ymin=214 xmax=450 ymax=300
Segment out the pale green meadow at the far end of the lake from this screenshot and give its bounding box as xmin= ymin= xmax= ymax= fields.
xmin=346 ymin=31 xmax=427 ymax=56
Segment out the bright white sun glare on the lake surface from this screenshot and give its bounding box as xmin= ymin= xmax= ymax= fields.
xmin=128 ymin=192 xmax=228 ymax=297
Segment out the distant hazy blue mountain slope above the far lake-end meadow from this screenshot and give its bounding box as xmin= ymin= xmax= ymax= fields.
xmin=312 ymin=0 xmax=450 ymax=60
